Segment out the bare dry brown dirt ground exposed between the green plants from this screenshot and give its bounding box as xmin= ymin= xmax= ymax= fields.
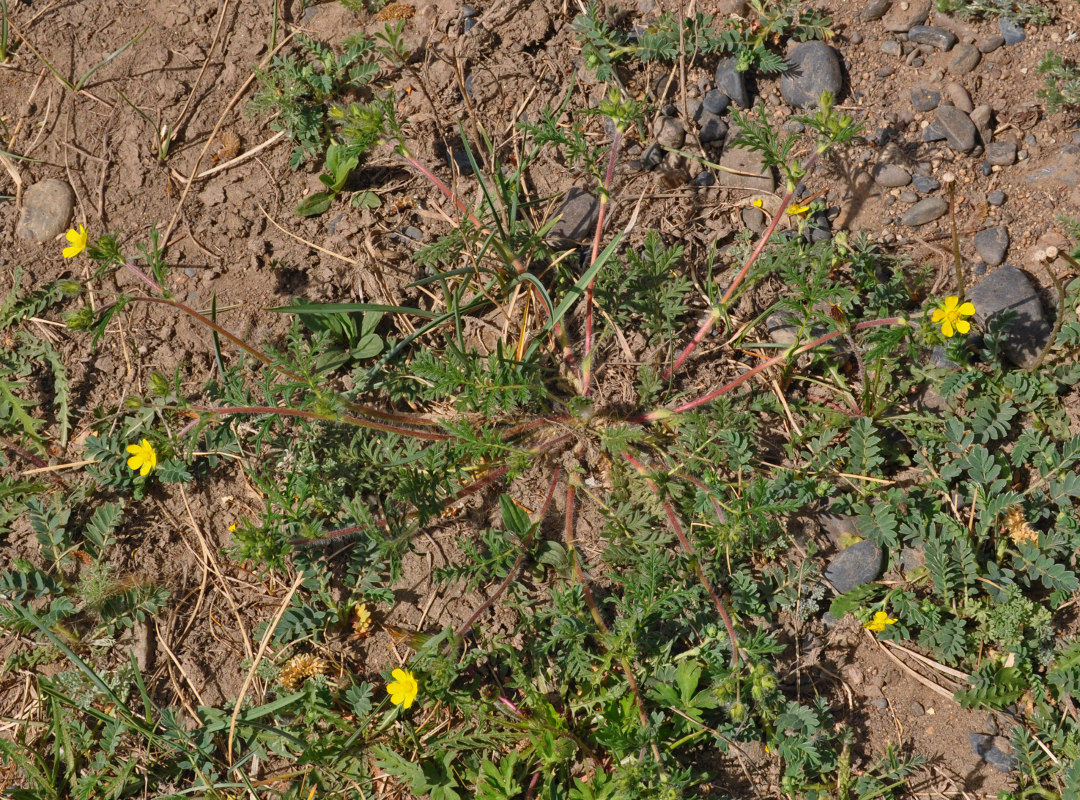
xmin=0 ymin=0 xmax=1080 ymax=796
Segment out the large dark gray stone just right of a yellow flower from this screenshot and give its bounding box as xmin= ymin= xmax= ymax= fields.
xmin=968 ymin=267 xmax=1050 ymax=368
